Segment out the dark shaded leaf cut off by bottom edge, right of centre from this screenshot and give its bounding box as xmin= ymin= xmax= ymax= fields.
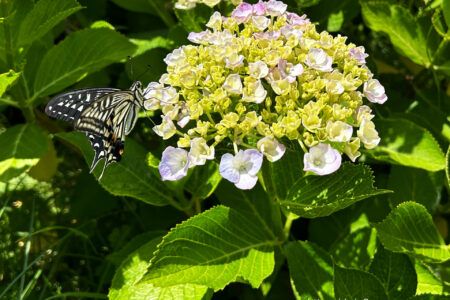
xmin=334 ymin=265 xmax=388 ymax=300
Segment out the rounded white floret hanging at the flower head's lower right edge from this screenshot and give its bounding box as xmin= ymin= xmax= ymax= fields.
xmin=303 ymin=144 xmax=342 ymax=175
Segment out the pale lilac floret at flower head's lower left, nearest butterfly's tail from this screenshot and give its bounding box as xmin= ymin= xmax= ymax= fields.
xmin=158 ymin=146 xmax=189 ymax=181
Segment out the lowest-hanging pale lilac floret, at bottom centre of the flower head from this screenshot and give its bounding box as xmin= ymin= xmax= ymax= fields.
xmin=219 ymin=149 xmax=263 ymax=190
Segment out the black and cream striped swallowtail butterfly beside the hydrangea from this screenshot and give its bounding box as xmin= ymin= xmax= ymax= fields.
xmin=45 ymin=81 xmax=144 ymax=180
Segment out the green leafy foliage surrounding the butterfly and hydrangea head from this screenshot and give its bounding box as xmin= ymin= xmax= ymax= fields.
xmin=0 ymin=0 xmax=450 ymax=299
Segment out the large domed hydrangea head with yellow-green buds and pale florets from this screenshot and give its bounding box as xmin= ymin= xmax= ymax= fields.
xmin=145 ymin=0 xmax=387 ymax=189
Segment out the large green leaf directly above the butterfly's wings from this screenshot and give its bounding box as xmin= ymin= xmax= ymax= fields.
xmin=33 ymin=28 xmax=136 ymax=99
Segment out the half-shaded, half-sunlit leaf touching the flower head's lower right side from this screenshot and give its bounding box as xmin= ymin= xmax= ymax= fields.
xmin=367 ymin=119 xmax=445 ymax=171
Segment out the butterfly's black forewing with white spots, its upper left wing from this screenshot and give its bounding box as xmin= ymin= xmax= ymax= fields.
xmin=45 ymin=88 xmax=120 ymax=124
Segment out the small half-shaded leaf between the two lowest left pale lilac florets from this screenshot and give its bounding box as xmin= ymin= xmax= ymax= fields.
xmin=184 ymin=161 xmax=222 ymax=199
